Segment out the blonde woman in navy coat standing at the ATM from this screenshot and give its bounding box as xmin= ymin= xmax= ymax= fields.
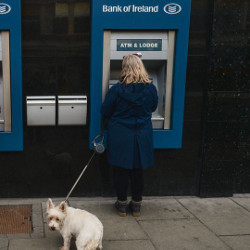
xmin=101 ymin=54 xmax=158 ymax=216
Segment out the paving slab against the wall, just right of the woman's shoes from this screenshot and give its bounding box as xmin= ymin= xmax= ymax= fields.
xmin=138 ymin=199 xmax=193 ymax=220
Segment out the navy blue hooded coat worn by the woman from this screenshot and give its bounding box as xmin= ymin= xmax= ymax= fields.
xmin=101 ymin=83 xmax=158 ymax=169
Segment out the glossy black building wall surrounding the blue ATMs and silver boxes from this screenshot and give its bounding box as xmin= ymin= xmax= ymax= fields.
xmin=0 ymin=0 xmax=250 ymax=197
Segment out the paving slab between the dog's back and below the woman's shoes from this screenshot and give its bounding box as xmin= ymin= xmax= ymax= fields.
xmin=103 ymin=217 xmax=148 ymax=240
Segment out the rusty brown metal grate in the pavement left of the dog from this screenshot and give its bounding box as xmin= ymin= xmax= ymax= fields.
xmin=0 ymin=205 xmax=32 ymax=234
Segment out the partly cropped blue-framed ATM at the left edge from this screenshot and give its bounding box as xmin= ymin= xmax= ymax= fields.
xmin=0 ymin=0 xmax=23 ymax=151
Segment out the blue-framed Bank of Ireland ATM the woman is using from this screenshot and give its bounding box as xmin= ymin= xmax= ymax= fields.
xmin=89 ymin=0 xmax=191 ymax=148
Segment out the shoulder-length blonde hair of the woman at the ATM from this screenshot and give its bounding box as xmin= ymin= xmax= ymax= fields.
xmin=119 ymin=55 xmax=152 ymax=84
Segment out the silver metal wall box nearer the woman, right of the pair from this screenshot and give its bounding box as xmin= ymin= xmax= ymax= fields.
xmin=58 ymin=95 xmax=87 ymax=125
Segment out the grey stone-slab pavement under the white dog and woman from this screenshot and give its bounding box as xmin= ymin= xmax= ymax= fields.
xmin=0 ymin=194 xmax=250 ymax=250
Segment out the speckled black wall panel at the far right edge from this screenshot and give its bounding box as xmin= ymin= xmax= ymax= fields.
xmin=200 ymin=0 xmax=250 ymax=196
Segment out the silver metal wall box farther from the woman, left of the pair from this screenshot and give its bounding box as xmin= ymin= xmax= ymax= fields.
xmin=26 ymin=96 xmax=56 ymax=126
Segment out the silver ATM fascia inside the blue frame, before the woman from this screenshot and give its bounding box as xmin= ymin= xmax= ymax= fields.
xmin=103 ymin=31 xmax=174 ymax=129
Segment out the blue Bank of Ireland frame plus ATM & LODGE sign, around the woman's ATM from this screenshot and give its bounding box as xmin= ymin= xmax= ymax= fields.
xmin=89 ymin=0 xmax=191 ymax=148
